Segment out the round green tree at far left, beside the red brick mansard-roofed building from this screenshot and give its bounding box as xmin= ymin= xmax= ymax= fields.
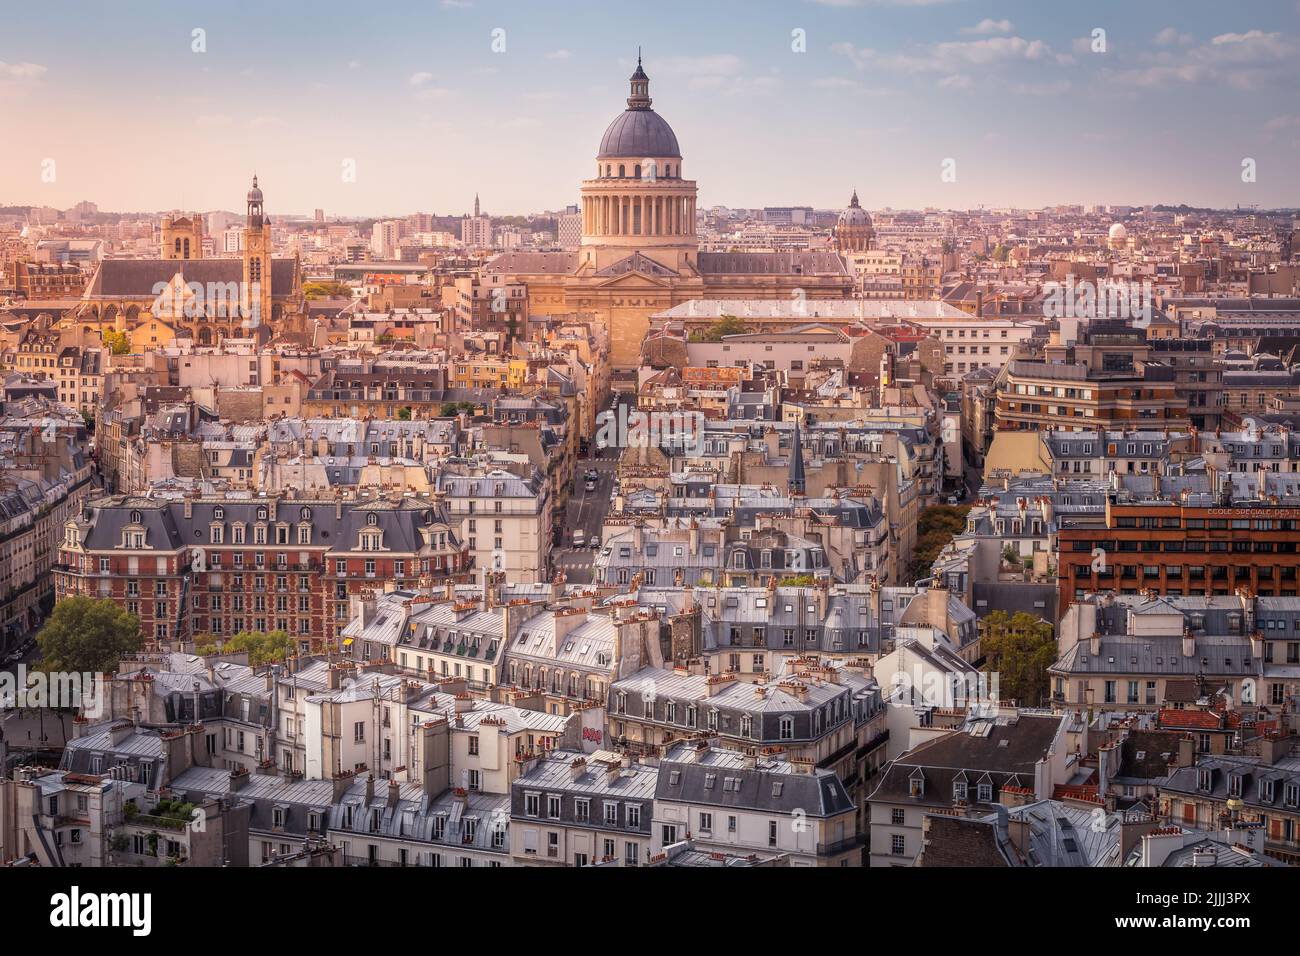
xmin=36 ymin=594 xmax=144 ymax=674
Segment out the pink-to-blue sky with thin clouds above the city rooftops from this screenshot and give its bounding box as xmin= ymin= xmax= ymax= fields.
xmin=0 ymin=0 xmax=1300 ymax=217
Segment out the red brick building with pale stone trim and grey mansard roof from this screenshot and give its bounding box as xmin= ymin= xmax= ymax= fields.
xmin=55 ymin=497 xmax=471 ymax=649
